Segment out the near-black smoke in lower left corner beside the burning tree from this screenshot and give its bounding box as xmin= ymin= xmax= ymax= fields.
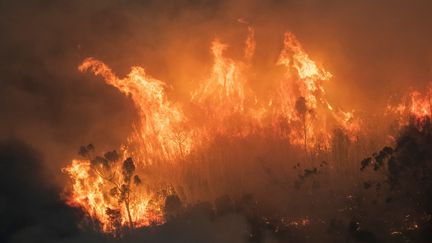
xmin=0 ymin=141 xmax=79 ymax=242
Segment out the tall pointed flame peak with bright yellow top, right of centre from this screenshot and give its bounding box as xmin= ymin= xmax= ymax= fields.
xmin=276 ymin=33 xmax=359 ymax=149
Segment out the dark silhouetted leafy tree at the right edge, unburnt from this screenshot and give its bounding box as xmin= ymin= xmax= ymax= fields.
xmin=361 ymin=118 xmax=432 ymax=211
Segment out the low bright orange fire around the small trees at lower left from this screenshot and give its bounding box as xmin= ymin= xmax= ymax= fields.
xmin=63 ymin=155 xmax=163 ymax=232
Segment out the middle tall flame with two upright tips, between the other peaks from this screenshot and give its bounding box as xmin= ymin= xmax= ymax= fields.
xmin=191 ymin=27 xmax=257 ymax=137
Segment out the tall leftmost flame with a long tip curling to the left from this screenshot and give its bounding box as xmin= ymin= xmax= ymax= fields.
xmin=78 ymin=58 xmax=191 ymax=163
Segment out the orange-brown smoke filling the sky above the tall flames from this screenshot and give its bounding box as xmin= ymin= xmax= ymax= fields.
xmin=0 ymin=0 xmax=432 ymax=177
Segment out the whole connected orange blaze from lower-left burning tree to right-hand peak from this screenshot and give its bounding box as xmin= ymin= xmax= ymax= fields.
xmin=64 ymin=27 xmax=362 ymax=232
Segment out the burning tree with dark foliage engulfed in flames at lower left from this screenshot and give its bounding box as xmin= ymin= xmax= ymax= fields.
xmin=65 ymin=144 xmax=165 ymax=236
